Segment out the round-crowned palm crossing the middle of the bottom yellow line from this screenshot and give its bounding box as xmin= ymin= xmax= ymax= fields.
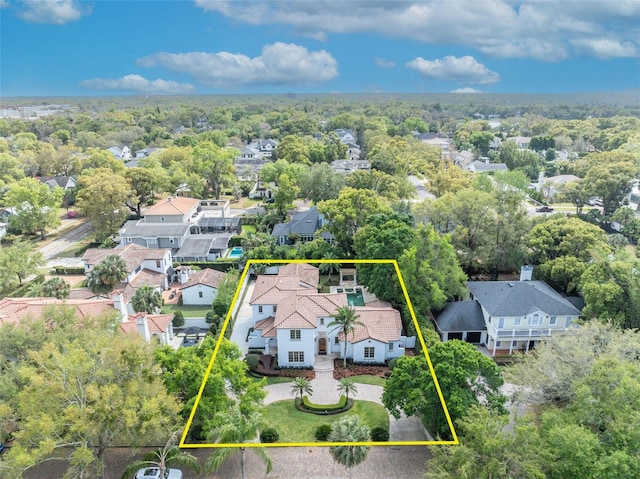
xmin=329 ymin=416 xmax=370 ymax=479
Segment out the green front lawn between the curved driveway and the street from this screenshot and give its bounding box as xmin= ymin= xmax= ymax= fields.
xmin=264 ymin=399 xmax=389 ymax=444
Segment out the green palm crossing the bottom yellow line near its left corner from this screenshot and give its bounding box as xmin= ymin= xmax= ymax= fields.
xmin=204 ymin=407 xmax=273 ymax=479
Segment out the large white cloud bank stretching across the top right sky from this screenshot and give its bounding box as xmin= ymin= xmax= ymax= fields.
xmin=195 ymin=0 xmax=640 ymax=61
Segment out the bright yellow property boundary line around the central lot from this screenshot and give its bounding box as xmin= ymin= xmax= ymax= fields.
xmin=178 ymin=259 xmax=460 ymax=449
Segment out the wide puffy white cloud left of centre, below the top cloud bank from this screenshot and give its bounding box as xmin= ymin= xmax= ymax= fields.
xmin=137 ymin=42 xmax=338 ymax=88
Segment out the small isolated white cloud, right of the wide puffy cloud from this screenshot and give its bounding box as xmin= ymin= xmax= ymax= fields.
xmin=407 ymin=55 xmax=500 ymax=85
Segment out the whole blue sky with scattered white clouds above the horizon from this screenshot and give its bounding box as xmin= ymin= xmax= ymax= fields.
xmin=0 ymin=0 xmax=640 ymax=97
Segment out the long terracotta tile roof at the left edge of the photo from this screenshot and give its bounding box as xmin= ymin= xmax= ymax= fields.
xmin=0 ymin=298 xmax=115 ymax=324
